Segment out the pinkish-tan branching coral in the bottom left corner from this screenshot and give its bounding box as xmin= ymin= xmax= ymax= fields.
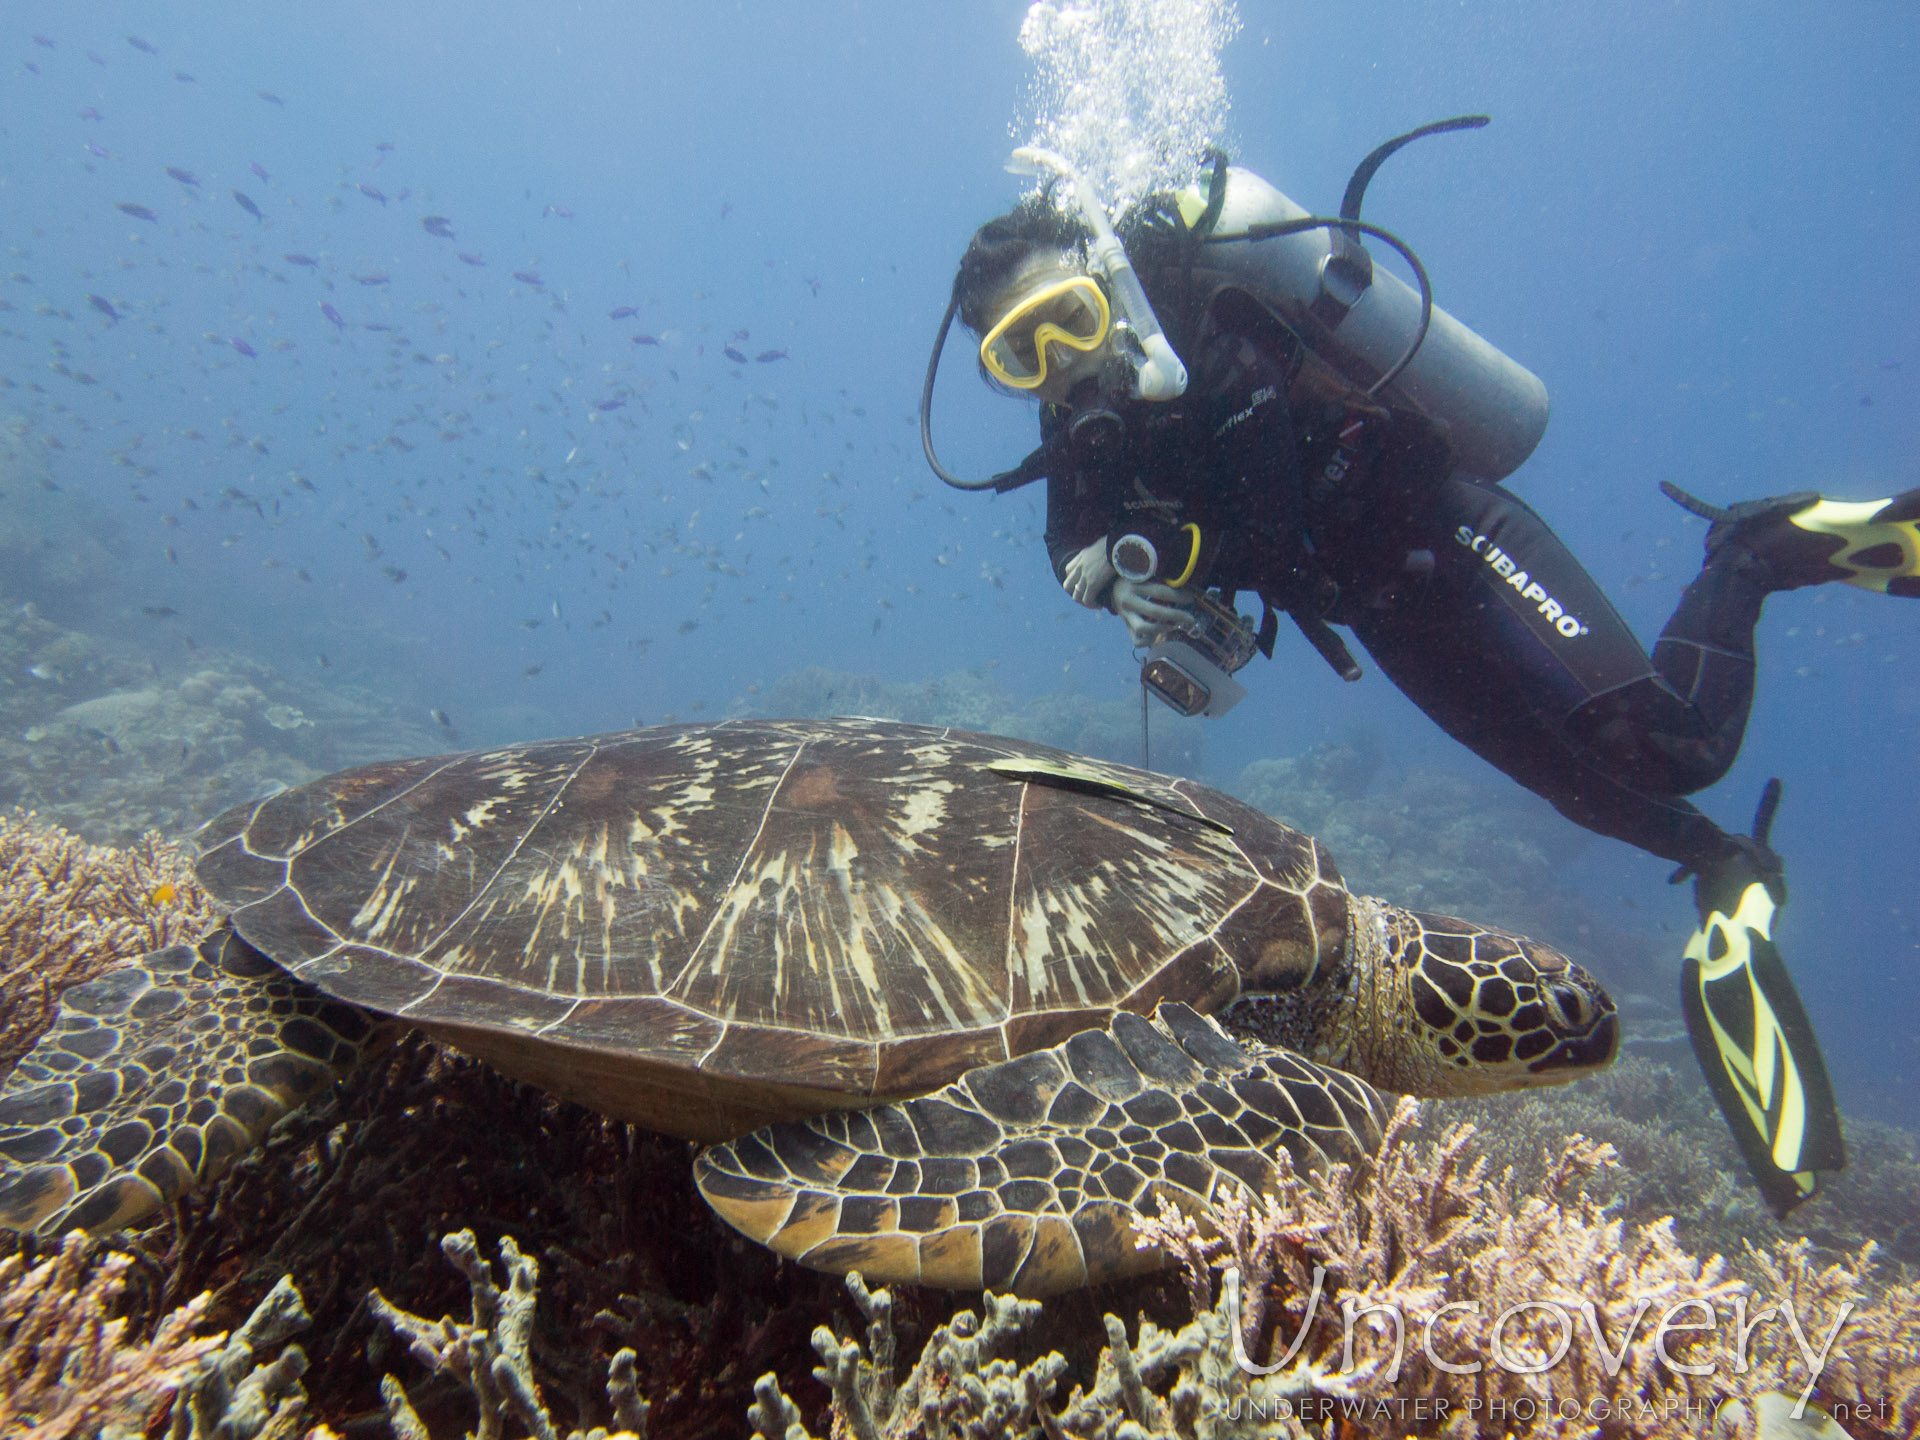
xmin=0 ymin=1233 xmax=219 ymax=1440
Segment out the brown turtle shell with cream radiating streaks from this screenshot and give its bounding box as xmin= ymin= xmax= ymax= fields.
xmin=198 ymin=720 xmax=1348 ymax=1140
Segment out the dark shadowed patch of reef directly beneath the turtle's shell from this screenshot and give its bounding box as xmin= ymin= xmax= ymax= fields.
xmin=91 ymin=1037 xmax=898 ymax=1440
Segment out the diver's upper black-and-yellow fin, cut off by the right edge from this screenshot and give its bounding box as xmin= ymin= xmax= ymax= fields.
xmin=1661 ymin=480 xmax=1920 ymax=599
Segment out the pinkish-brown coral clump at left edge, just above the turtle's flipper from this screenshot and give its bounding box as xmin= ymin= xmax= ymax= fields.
xmin=0 ymin=814 xmax=213 ymax=1073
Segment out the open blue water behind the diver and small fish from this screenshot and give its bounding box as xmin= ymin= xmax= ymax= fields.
xmin=0 ymin=0 xmax=1920 ymax=1123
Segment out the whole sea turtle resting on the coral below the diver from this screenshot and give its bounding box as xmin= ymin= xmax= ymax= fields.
xmin=0 ymin=720 xmax=1619 ymax=1294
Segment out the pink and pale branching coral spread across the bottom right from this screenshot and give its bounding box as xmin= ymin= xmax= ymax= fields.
xmin=749 ymin=1100 xmax=1920 ymax=1440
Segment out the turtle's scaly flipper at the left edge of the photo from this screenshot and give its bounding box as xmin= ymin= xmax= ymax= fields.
xmin=0 ymin=925 xmax=385 ymax=1235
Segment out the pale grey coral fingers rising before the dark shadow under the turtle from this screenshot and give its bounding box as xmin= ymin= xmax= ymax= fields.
xmin=367 ymin=1231 xmax=651 ymax=1440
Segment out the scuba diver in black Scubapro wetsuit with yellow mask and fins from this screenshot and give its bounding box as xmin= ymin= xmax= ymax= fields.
xmin=922 ymin=115 xmax=1920 ymax=1217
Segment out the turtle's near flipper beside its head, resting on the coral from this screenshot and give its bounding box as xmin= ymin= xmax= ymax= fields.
xmin=695 ymin=1002 xmax=1386 ymax=1296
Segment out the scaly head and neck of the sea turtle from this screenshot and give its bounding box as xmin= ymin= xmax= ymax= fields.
xmin=1227 ymin=895 xmax=1620 ymax=1098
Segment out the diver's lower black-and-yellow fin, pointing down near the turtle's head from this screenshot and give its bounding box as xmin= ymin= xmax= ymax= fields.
xmin=1680 ymin=780 xmax=1847 ymax=1217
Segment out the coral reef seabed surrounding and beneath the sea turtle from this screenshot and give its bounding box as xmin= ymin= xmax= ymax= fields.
xmin=0 ymin=675 xmax=1920 ymax=1440
